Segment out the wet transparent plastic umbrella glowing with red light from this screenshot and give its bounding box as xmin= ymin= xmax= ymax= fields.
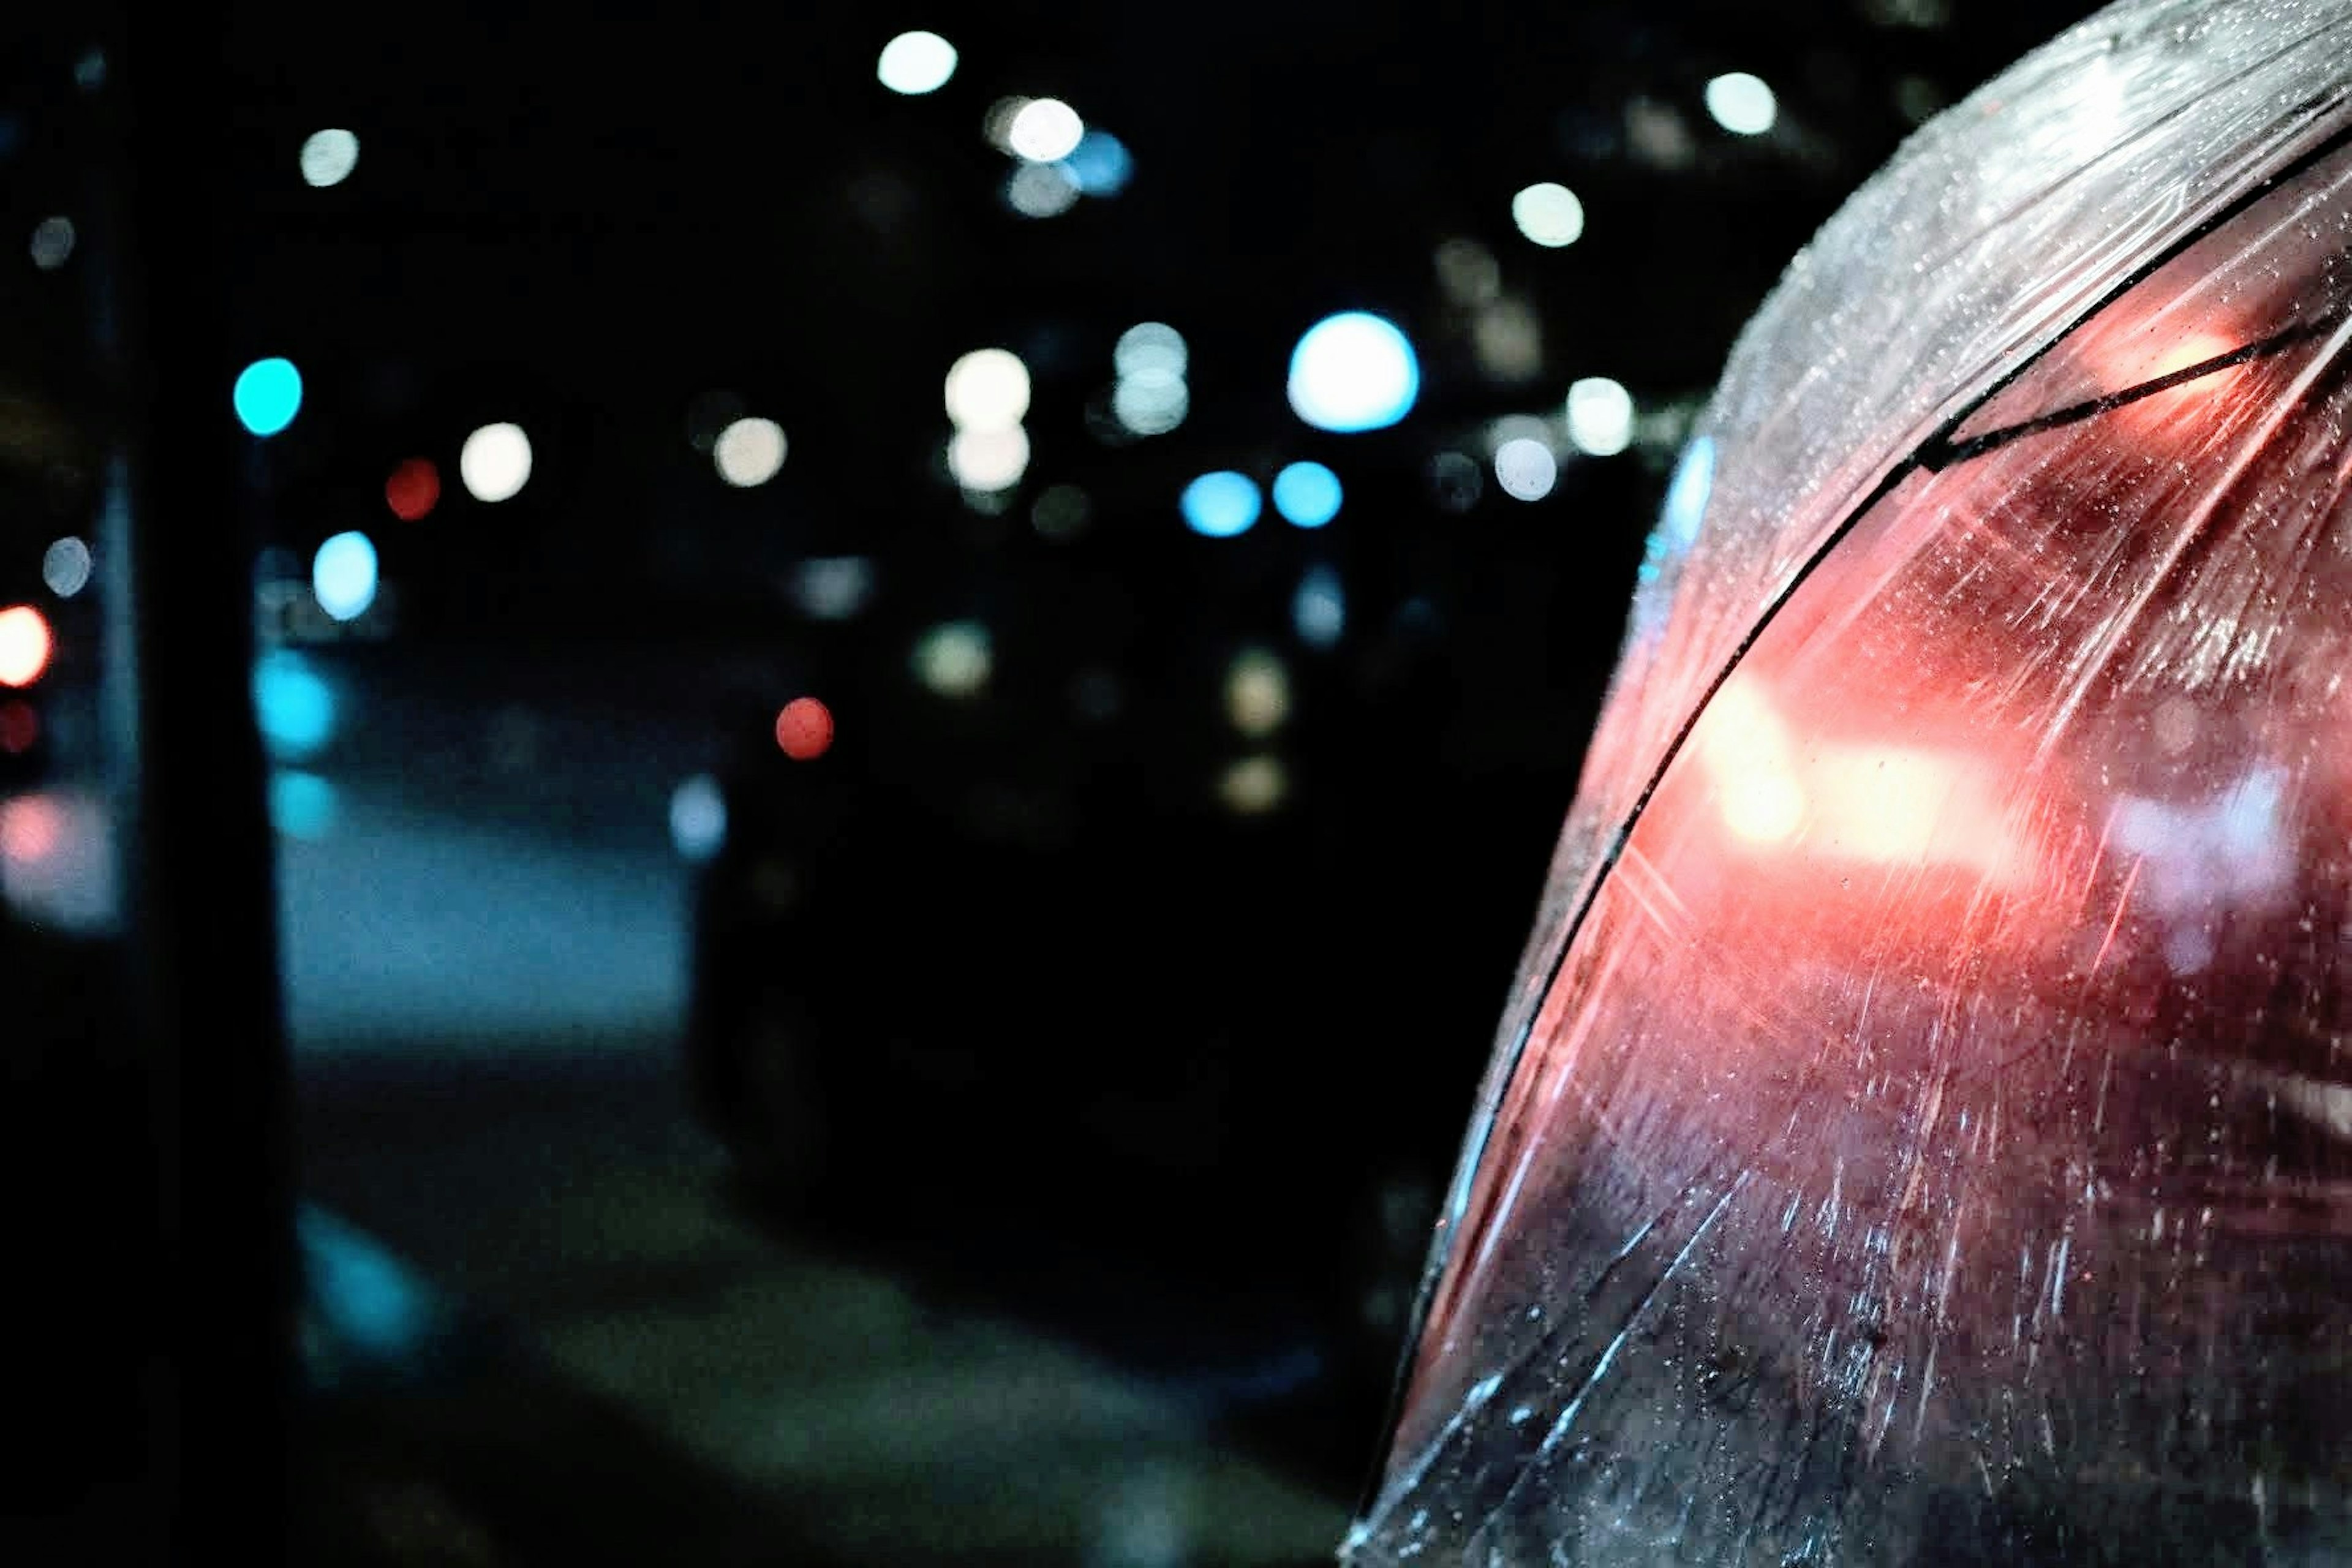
xmin=1343 ymin=0 xmax=2352 ymax=1568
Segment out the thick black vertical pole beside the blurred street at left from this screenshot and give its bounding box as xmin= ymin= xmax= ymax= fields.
xmin=85 ymin=0 xmax=296 ymax=1563
